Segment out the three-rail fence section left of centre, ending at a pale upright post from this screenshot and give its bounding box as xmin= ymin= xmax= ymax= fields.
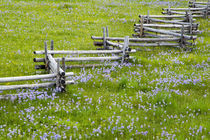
xmin=34 ymin=37 xmax=136 ymax=69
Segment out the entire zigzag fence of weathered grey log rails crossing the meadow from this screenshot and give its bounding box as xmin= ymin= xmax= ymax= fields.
xmin=0 ymin=0 xmax=210 ymax=98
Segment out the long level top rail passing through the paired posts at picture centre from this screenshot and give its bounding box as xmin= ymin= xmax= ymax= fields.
xmin=92 ymin=36 xmax=180 ymax=42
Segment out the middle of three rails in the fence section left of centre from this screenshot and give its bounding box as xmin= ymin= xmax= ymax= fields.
xmin=34 ymin=56 xmax=122 ymax=62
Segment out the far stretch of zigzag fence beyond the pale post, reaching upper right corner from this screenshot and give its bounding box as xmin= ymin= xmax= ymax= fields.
xmin=91 ymin=1 xmax=209 ymax=50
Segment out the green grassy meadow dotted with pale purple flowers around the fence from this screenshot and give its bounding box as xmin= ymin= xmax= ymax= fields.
xmin=0 ymin=0 xmax=210 ymax=139
